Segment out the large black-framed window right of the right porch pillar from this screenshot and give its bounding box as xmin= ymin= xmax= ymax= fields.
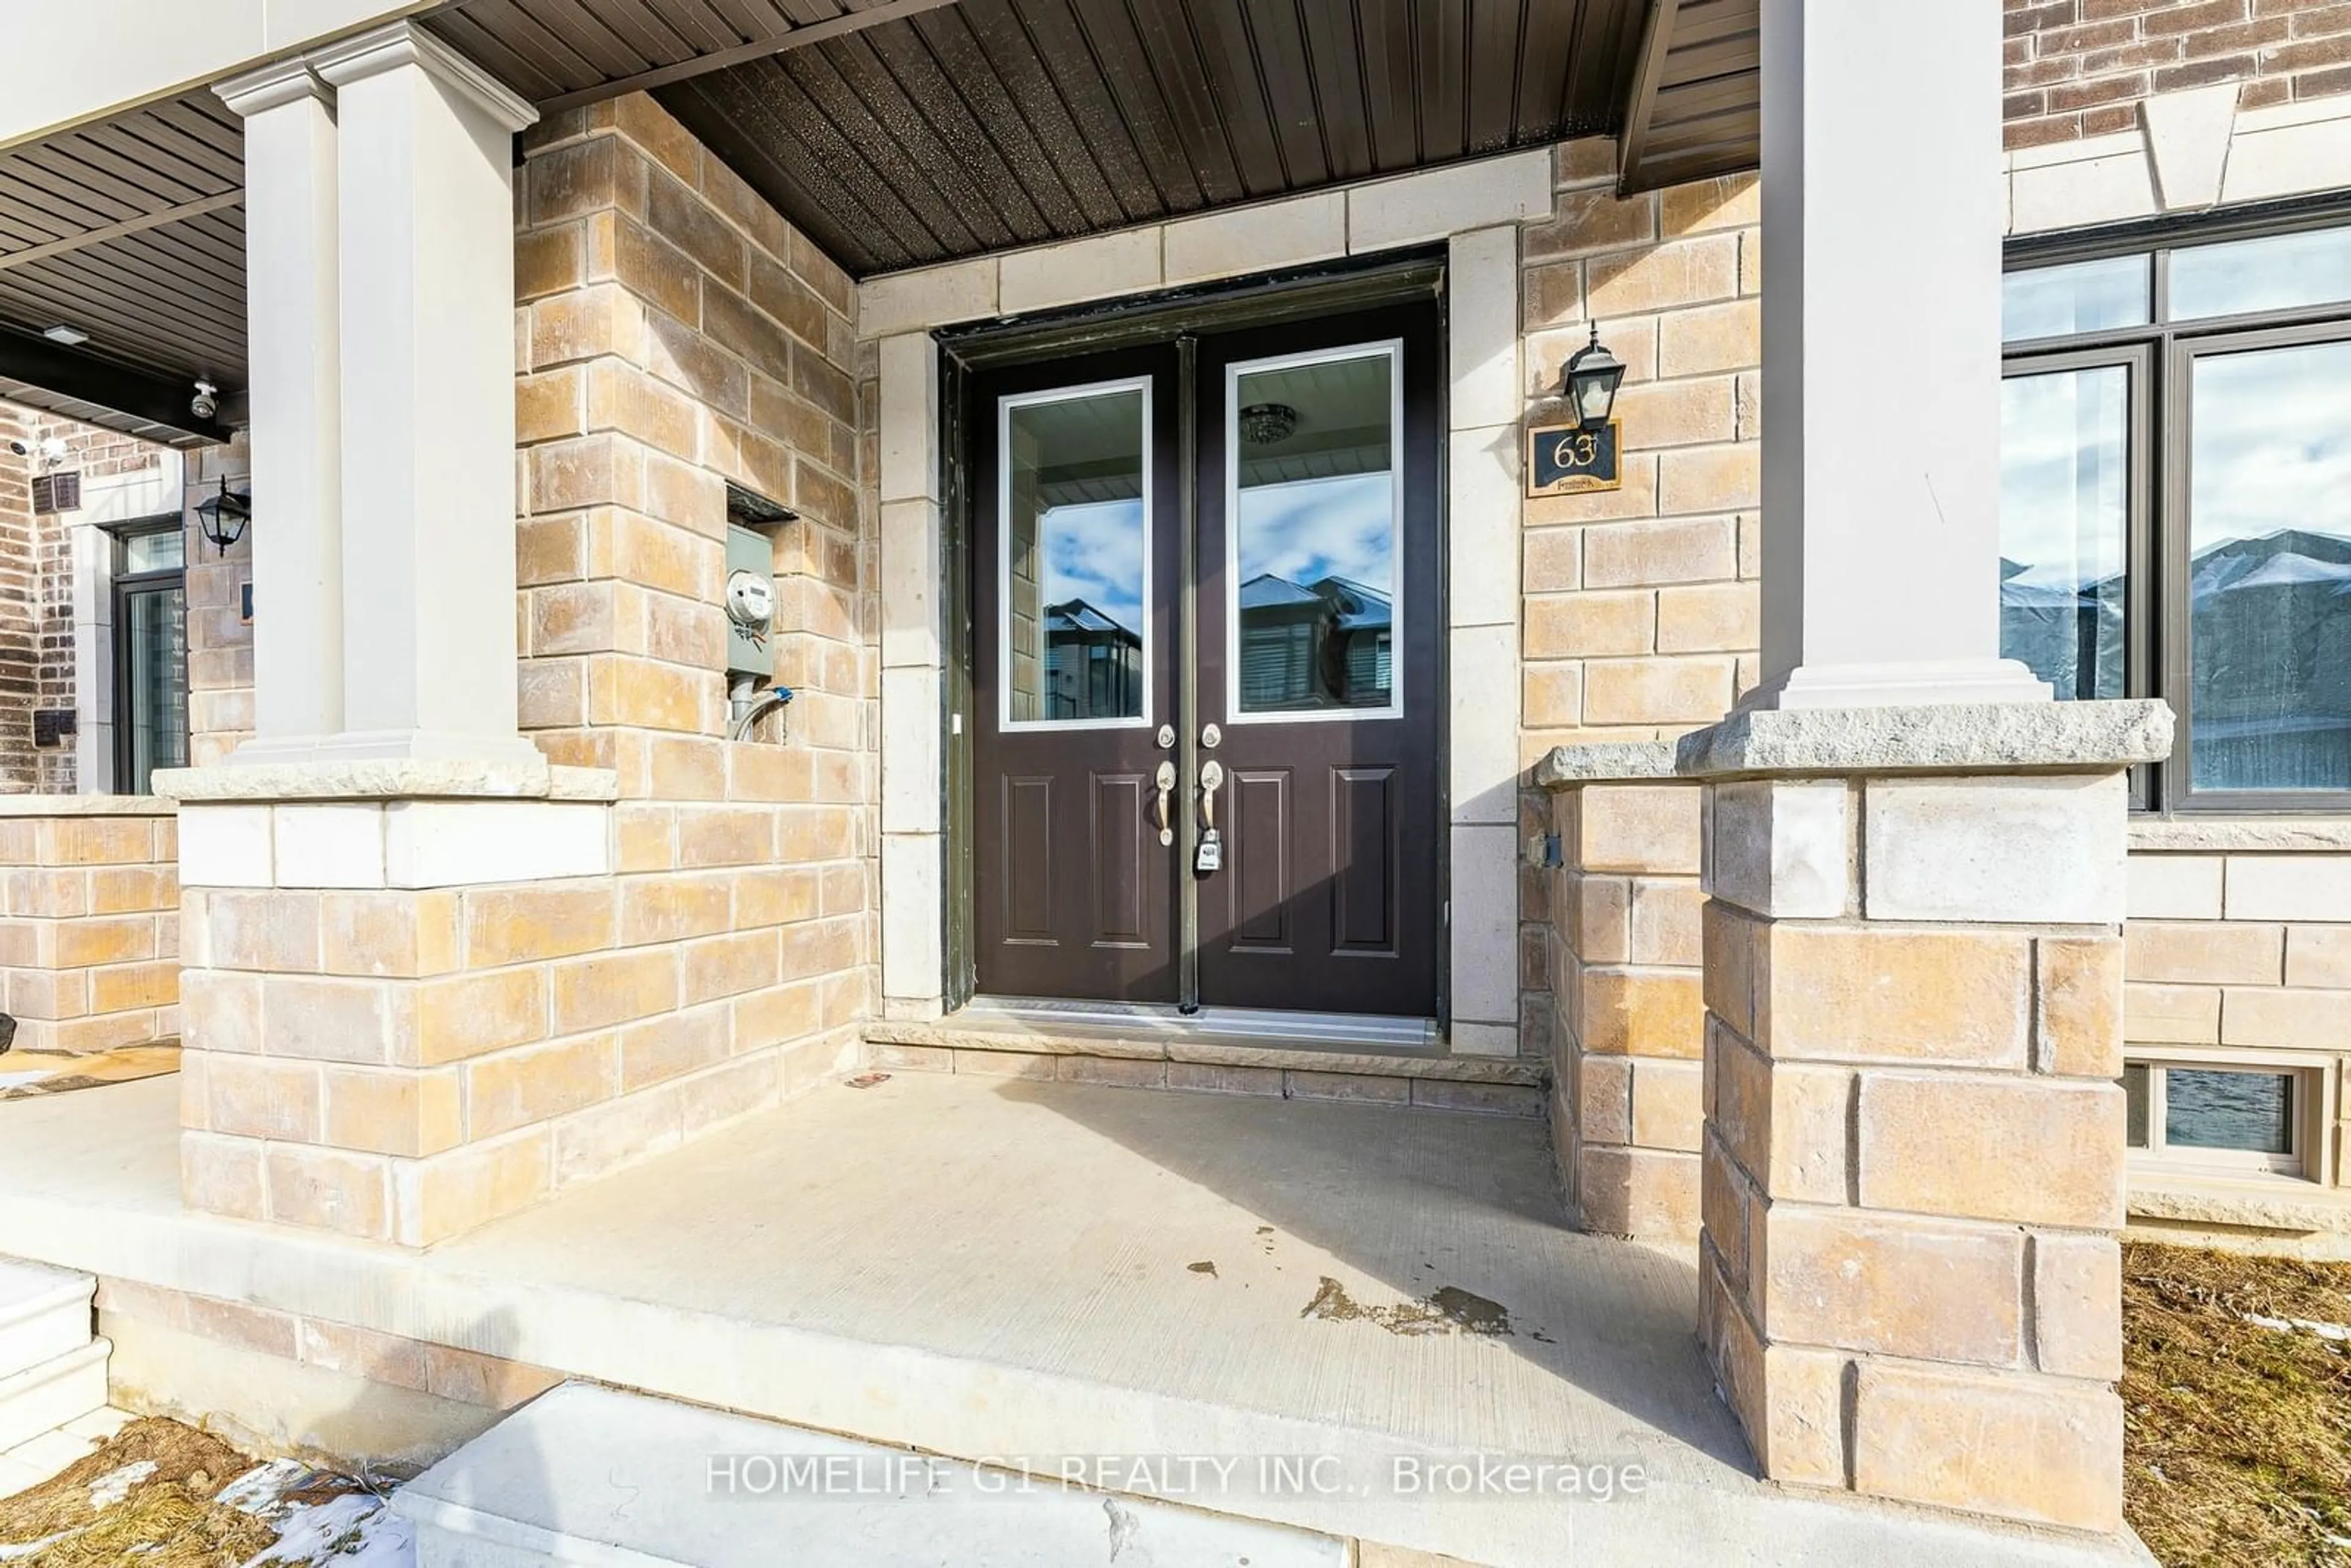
xmin=2001 ymin=214 xmax=2351 ymax=811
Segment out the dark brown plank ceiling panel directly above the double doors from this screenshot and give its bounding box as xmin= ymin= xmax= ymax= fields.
xmin=656 ymin=0 xmax=1643 ymax=275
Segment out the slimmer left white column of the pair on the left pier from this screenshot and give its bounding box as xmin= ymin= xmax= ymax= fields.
xmin=214 ymin=61 xmax=343 ymax=762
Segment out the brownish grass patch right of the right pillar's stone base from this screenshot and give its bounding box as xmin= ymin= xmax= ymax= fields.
xmin=2123 ymin=1241 xmax=2351 ymax=1568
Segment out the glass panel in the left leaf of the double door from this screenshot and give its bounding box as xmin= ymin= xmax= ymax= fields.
xmin=999 ymin=381 xmax=1152 ymax=726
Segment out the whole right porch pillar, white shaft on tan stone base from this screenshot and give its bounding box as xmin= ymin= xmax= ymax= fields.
xmin=1674 ymin=0 xmax=2172 ymax=1532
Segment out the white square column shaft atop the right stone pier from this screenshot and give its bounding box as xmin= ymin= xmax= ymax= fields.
xmin=1744 ymin=0 xmax=2050 ymax=708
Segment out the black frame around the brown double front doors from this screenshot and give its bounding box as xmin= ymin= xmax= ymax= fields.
xmin=933 ymin=244 xmax=1453 ymax=1030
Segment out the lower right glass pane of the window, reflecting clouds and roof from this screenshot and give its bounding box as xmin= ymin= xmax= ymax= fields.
xmin=2189 ymin=341 xmax=2351 ymax=790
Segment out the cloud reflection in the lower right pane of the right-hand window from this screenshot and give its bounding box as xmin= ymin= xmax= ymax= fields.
xmin=2189 ymin=343 xmax=2351 ymax=555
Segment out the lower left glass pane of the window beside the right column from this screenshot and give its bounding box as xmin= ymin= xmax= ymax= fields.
xmin=2001 ymin=364 xmax=2130 ymax=698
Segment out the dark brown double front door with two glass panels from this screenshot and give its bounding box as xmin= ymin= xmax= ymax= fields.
xmin=969 ymin=306 xmax=1439 ymax=1016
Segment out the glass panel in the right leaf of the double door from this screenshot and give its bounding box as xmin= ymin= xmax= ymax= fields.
xmin=1225 ymin=345 xmax=1401 ymax=717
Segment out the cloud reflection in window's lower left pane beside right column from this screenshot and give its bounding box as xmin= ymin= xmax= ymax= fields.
xmin=2001 ymin=367 xmax=2130 ymax=588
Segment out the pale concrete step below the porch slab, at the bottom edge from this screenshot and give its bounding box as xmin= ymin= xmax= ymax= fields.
xmin=392 ymin=1382 xmax=1349 ymax=1568
